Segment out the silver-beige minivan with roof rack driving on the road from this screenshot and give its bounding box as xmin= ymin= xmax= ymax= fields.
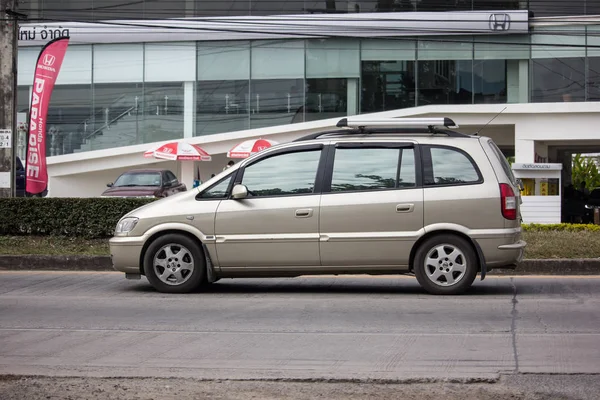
xmin=110 ymin=117 xmax=526 ymax=294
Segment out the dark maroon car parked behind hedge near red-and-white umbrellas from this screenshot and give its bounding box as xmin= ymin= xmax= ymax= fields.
xmin=102 ymin=169 xmax=187 ymax=197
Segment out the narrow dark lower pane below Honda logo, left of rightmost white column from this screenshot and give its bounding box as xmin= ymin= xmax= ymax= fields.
xmin=473 ymin=60 xmax=507 ymax=104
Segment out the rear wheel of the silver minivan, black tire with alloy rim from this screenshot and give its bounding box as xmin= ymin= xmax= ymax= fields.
xmin=413 ymin=234 xmax=479 ymax=295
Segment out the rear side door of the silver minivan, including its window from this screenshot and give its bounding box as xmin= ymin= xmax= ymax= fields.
xmin=320 ymin=143 xmax=423 ymax=267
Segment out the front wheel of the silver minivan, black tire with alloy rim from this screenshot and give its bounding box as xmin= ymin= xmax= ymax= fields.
xmin=144 ymin=233 xmax=206 ymax=293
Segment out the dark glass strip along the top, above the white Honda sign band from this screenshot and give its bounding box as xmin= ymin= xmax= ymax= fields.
xmin=19 ymin=0 xmax=600 ymax=21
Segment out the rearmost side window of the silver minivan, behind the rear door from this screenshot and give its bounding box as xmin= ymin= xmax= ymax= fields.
xmin=423 ymin=146 xmax=483 ymax=186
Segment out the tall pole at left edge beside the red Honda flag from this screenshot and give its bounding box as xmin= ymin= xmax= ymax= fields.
xmin=0 ymin=0 xmax=19 ymax=197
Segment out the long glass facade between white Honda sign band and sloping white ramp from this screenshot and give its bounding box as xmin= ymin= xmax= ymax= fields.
xmin=18 ymin=25 xmax=600 ymax=155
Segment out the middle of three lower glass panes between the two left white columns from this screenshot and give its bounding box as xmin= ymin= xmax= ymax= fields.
xmin=248 ymin=79 xmax=304 ymax=128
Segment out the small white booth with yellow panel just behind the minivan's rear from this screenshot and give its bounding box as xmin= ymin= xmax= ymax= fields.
xmin=512 ymin=163 xmax=563 ymax=224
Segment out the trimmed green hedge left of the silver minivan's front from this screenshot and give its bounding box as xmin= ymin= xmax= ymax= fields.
xmin=0 ymin=197 xmax=154 ymax=239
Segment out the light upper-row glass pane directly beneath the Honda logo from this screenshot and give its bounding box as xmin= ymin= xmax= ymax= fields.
xmin=475 ymin=35 xmax=530 ymax=60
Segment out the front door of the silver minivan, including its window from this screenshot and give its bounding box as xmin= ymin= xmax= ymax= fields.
xmin=215 ymin=144 xmax=325 ymax=270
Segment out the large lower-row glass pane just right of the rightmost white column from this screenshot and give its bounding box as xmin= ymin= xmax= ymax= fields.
xmin=531 ymin=57 xmax=585 ymax=103
